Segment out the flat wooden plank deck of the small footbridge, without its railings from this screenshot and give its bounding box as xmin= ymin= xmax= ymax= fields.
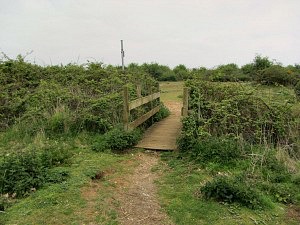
xmin=135 ymin=102 xmax=181 ymax=150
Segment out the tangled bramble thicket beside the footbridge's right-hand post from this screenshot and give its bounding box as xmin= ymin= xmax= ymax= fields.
xmin=183 ymin=80 xmax=296 ymax=144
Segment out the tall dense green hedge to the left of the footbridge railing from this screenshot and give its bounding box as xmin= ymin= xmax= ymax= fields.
xmin=0 ymin=57 xmax=158 ymax=135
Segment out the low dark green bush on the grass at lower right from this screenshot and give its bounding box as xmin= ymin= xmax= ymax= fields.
xmin=200 ymin=176 xmax=266 ymax=209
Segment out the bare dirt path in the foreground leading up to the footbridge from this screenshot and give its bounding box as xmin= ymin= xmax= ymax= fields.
xmin=115 ymin=152 xmax=173 ymax=225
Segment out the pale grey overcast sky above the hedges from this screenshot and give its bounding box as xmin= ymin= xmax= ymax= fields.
xmin=0 ymin=0 xmax=300 ymax=67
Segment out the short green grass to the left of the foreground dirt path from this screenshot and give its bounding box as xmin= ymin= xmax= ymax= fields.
xmin=0 ymin=133 xmax=137 ymax=224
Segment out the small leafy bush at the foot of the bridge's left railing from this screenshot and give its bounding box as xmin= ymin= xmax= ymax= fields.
xmin=92 ymin=127 xmax=141 ymax=152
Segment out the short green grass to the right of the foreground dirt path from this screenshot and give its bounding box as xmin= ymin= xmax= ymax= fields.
xmin=157 ymin=153 xmax=299 ymax=225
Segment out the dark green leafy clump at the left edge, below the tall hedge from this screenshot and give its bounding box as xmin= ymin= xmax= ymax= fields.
xmin=0 ymin=145 xmax=71 ymax=197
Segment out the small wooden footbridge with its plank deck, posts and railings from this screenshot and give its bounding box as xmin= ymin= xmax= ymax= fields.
xmin=124 ymin=85 xmax=188 ymax=150
